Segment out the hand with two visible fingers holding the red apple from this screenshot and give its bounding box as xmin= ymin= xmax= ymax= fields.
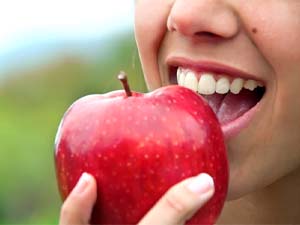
xmin=60 ymin=173 xmax=214 ymax=225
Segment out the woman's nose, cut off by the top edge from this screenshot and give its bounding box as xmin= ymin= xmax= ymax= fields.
xmin=167 ymin=0 xmax=239 ymax=38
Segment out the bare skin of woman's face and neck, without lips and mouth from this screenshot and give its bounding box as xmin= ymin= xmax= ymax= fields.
xmin=135 ymin=0 xmax=300 ymax=224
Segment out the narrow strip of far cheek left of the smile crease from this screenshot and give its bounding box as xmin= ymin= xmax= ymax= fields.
xmin=135 ymin=0 xmax=173 ymax=90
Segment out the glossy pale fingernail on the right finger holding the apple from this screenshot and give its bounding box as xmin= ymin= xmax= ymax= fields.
xmin=187 ymin=173 xmax=214 ymax=194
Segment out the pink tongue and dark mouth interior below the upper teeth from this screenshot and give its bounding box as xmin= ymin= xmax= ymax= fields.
xmin=204 ymin=89 xmax=261 ymax=125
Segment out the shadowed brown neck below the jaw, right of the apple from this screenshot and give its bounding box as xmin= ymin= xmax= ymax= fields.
xmin=218 ymin=168 xmax=300 ymax=224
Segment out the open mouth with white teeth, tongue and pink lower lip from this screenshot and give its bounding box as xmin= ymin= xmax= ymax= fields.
xmin=169 ymin=66 xmax=266 ymax=137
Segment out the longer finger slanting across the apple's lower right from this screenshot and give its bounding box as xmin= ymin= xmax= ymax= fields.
xmin=139 ymin=173 xmax=214 ymax=225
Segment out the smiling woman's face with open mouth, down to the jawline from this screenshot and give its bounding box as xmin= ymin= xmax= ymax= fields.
xmin=135 ymin=0 xmax=300 ymax=199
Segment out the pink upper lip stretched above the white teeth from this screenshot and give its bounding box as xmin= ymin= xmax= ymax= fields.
xmin=166 ymin=57 xmax=265 ymax=83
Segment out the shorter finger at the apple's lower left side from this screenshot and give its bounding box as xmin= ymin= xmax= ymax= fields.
xmin=59 ymin=173 xmax=97 ymax=225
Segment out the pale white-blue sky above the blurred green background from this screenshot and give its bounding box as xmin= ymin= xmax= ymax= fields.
xmin=0 ymin=0 xmax=134 ymax=70
